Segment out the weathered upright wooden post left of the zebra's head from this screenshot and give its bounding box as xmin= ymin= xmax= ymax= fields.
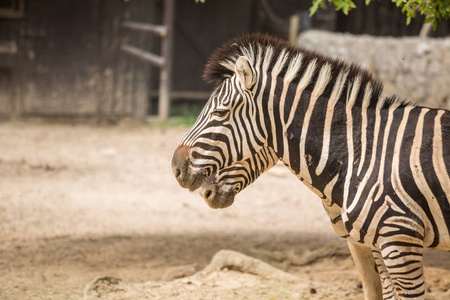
xmin=158 ymin=0 xmax=175 ymax=120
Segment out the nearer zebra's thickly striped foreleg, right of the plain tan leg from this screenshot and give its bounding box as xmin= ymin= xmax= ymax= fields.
xmin=380 ymin=236 xmax=425 ymax=300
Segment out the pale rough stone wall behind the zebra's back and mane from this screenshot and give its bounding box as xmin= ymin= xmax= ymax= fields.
xmin=297 ymin=30 xmax=450 ymax=109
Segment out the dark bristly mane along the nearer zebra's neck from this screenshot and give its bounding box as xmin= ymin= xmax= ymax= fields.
xmin=203 ymin=33 xmax=412 ymax=108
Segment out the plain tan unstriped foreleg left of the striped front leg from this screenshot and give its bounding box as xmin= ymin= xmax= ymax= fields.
xmin=347 ymin=241 xmax=383 ymax=300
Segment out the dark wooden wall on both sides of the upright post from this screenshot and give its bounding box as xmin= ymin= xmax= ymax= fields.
xmin=0 ymin=0 xmax=255 ymax=117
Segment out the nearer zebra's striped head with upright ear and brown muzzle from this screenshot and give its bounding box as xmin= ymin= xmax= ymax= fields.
xmin=172 ymin=51 xmax=265 ymax=195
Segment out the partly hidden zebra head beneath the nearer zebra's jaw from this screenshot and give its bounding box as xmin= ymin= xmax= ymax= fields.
xmin=200 ymin=147 xmax=278 ymax=208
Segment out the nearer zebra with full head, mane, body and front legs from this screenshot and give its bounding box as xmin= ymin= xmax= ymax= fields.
xmin=172 ymin=34 xmax=450 ymax=299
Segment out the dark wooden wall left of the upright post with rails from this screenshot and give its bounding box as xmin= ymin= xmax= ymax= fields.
xmin=0 ymin=0 xmax=155 ymax=116
